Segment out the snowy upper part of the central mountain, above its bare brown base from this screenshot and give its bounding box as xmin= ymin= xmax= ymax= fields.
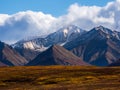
xmin=12 ymin=25 xmax=85 ymax=51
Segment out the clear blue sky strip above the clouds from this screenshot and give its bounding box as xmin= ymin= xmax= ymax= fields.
xmin=0 ymin=0 xmax=114 ymax=17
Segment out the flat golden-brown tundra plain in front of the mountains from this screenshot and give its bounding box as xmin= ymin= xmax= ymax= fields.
xmin=0 ymin=66 xmax=120 ymax=90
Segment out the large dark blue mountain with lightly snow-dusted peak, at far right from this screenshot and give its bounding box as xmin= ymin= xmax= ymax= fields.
xmin=65 ymin=26 xmax=120 ymax=66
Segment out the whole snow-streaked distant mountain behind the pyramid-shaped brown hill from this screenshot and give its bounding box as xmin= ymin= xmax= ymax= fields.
xmin=12 ymin=25 xmax=86 ymax=61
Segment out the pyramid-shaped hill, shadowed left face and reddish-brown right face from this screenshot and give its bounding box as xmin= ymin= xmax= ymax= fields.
xmin=27 ymin=45 xmax=89 ymax=65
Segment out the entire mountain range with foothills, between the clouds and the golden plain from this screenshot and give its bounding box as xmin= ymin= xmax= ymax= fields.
xmin=0 ymin=25 xmax=120 ymax=66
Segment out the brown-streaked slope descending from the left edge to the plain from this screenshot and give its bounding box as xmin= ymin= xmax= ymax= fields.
xmin=0 ymin=42 xmax=27 ymax=66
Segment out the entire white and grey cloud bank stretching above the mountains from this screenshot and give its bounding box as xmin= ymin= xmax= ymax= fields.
xmin=0 ymin=0 xmax=120 ymax=43
